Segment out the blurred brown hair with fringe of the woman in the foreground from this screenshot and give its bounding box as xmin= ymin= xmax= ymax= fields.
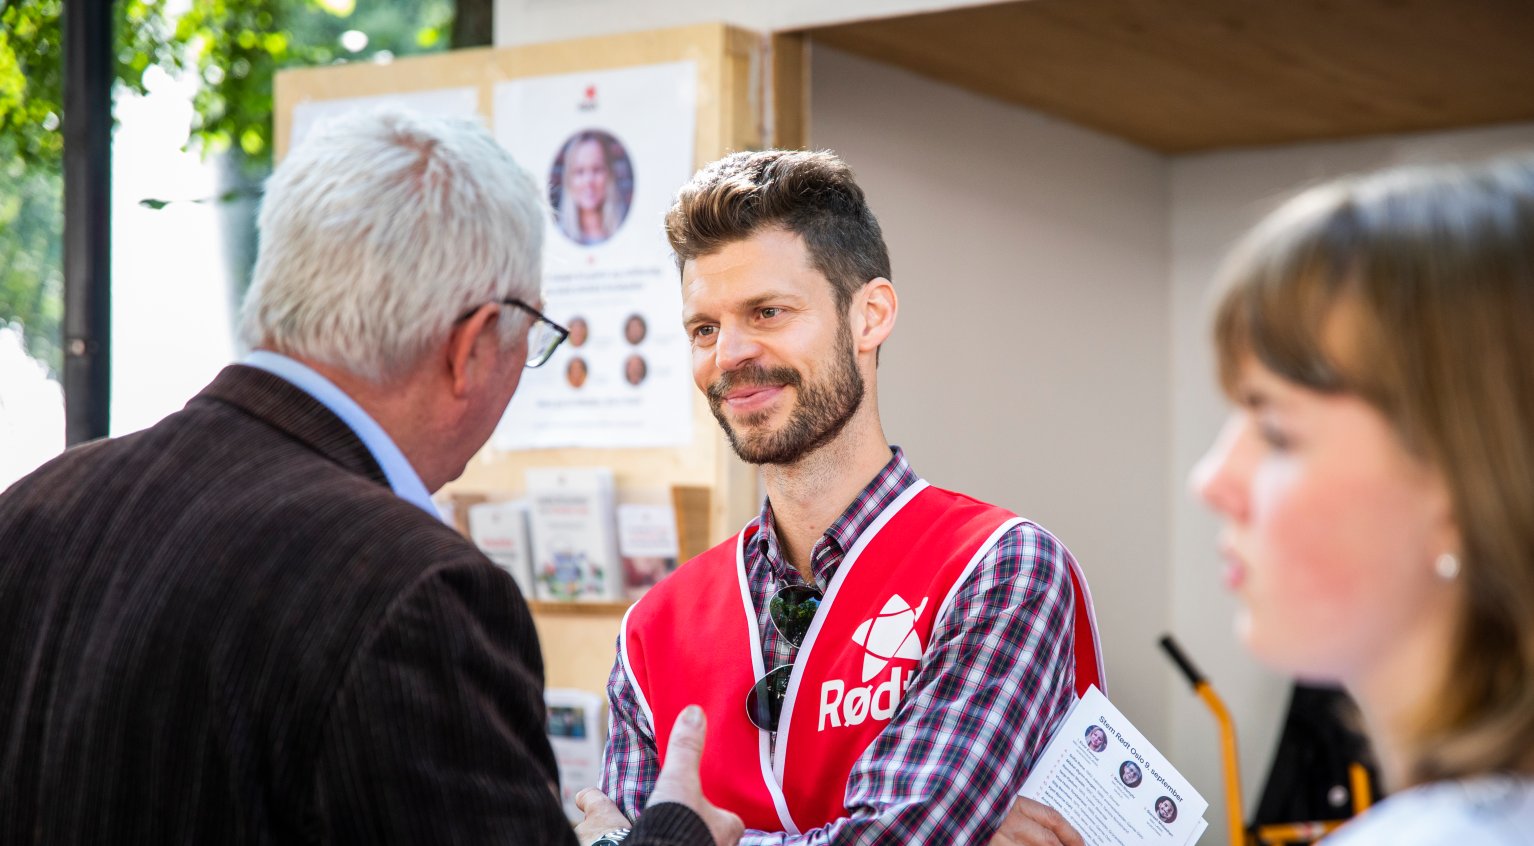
xmin=1215 ymin=158 xmax=1534 ymax=782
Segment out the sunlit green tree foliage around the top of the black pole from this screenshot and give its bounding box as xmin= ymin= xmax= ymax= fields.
xmin=0 ymin=0 xmax=454 ymax=372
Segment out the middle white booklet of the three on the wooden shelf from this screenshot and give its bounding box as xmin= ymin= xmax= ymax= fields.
xmin=526 ymin=467 xmax=623 ymax=602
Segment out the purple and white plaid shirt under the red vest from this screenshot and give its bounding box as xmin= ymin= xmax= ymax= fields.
xmin=603 ymin=447 xmax=1075 ymax=846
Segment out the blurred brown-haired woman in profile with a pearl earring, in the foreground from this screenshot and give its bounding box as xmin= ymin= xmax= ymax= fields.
xmin=1193 ymin=158 xmax=1534 ymax=846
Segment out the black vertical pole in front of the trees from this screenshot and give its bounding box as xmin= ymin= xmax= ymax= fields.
xmin=61 ymin=0 xmax=112 ymax=445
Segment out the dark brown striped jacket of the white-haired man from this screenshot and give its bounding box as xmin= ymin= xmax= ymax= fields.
xmin=0 ymin=365 xmax=707 ymax=846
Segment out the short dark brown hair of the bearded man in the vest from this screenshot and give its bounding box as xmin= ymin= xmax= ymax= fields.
xmin=666 ymin=150 xmax=890 ymax=310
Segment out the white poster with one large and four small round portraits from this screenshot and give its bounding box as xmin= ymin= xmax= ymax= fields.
xmin=492 ymin=61 xmax=698 ymax=450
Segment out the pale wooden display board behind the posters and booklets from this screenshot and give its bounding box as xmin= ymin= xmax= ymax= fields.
xmin=276 ymin=25 xmax=804 ymax=703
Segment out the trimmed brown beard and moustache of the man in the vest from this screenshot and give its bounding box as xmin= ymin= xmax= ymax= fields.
xmin=707 ymin=321 xmax=864 ymax=464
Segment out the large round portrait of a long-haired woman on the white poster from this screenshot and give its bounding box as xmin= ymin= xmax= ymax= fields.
xmin=549 ymin=129 xmax=634 ymax=246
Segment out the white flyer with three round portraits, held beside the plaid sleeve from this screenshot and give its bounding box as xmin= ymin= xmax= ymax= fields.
xmin=1019 ymin=686 xmax=1209 ymax=846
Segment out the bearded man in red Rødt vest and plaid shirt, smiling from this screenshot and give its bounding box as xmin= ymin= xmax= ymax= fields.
xmin=586 ymin=150 xmax=1101 ymax=844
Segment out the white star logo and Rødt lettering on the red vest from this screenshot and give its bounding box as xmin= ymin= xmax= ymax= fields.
xmin=816 ymin=594 xmax=928 ymax=731
